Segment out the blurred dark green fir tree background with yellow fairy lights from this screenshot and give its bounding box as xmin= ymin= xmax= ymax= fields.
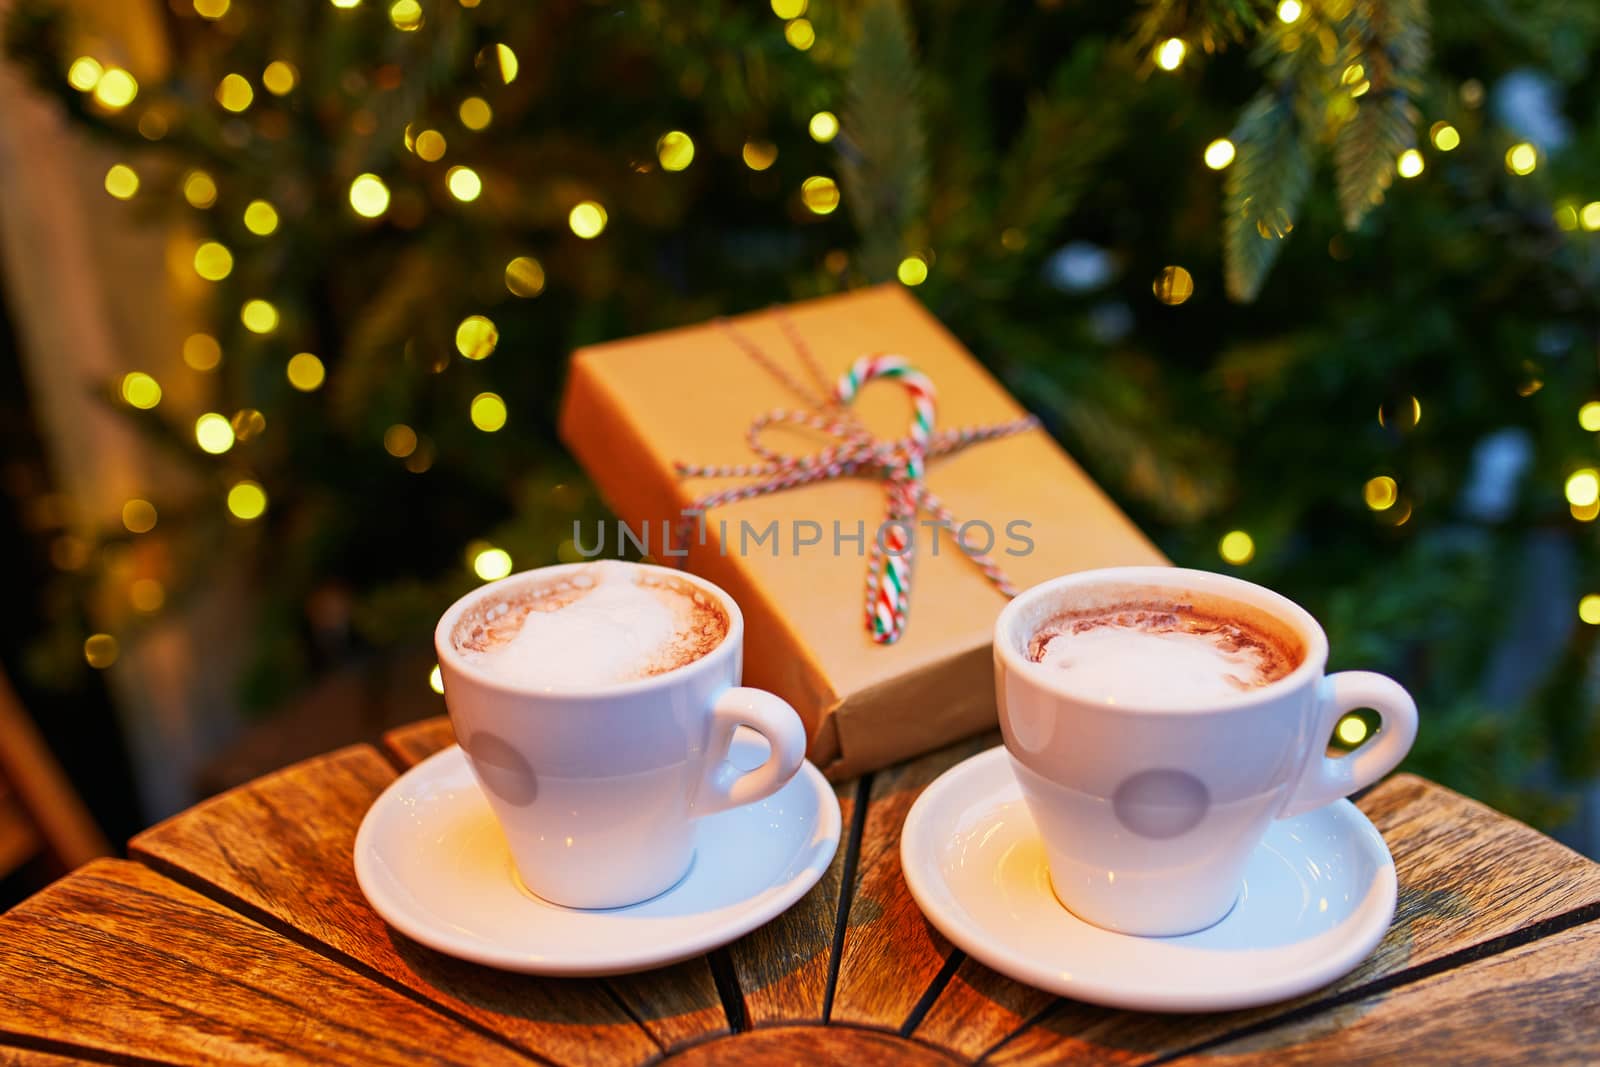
xmin=0 ymin=0 xmax=1600 ymax=899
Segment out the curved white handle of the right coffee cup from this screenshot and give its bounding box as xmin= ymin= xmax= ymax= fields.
xmin=1278 ymin=670 xmax=1416 ymax=819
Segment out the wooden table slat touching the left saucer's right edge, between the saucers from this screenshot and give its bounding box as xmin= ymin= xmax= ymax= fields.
xmin=728 ymin=781 xmax=856 ymax=1027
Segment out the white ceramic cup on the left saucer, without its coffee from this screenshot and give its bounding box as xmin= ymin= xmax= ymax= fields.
xmin=434 ymin=563 xmax=806 ymax=909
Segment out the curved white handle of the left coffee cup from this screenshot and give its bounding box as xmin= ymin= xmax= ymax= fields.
xmin=694 ymin=686 xmax=805 ymax=817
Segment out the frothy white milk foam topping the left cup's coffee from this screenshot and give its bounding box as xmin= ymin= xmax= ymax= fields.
xmin=462 ymin=560 xmax=720 ymax=689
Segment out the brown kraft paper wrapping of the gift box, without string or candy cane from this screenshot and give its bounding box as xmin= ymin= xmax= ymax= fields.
xmin=560 ymin=285 xmax=1166 ymax=777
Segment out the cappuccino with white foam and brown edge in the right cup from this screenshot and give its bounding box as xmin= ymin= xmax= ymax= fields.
xmin=1024 ymin=598 xmax=1304 ymax=707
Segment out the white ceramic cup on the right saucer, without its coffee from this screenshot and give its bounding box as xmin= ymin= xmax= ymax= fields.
xmin=994 ymin=566 xmax=1416 ymax=936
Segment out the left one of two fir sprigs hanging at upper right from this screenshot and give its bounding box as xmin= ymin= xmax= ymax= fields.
xmin=1222 ymin=93 xmax=1312 ymax=302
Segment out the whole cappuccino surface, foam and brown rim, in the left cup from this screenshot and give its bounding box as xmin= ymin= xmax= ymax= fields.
xmin=453 ymin=560 xmax=728 ymax=689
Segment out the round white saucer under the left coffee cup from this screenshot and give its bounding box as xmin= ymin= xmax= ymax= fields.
xmin=355 ymin=739 xmax=840 ymax=976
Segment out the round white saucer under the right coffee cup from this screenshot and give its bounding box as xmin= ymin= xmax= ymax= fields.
xmin=901 ymin=747 xmax=1395 ymax=1011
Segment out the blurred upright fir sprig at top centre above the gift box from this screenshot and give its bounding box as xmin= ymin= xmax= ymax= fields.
xmin=838 ymin=0 xmax=928 ymax=282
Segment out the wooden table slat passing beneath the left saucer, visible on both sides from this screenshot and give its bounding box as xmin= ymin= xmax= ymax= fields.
xmin=384 ymin=717 xmax=728 ymax=1049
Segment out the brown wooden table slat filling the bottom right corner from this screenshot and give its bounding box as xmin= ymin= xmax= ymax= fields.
xmin=1174 ymin=923 xmax=1600 ymax=1067
